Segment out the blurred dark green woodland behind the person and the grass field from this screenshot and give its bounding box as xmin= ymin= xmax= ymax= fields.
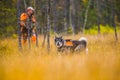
xmin=0 ymin=0 xmax=120 ymax=37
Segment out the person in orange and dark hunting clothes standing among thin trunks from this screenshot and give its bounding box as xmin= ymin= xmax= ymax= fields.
xmin=20 ymin=7 xmax=36 ymax=44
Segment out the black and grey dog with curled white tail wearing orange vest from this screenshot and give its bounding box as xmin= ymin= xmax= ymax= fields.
xmin=54 ymin=36 xmax=88 ymax=52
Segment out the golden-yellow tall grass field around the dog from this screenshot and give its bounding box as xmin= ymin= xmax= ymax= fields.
xmin=0 ymin=34 xmax=120 ymax=80
